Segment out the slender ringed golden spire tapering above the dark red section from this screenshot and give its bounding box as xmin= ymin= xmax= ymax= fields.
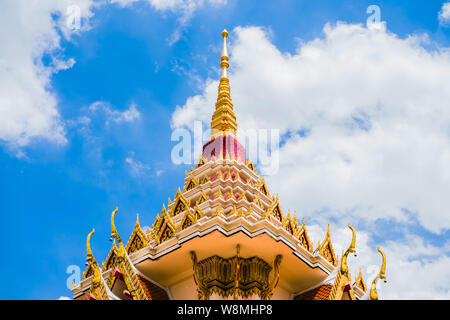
xmin=211 ymin=30 xmax=237 ymax=137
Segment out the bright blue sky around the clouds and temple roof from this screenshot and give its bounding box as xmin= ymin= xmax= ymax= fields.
xmin=0 ymin=0 xmax=450 ymax=299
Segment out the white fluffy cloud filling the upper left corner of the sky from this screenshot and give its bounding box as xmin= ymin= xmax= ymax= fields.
xmin=0 ymin=0 xmax=97 ymax=148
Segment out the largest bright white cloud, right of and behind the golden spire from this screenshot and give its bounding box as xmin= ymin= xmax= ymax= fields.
xmin=172 ymin=24 xmax=450 ymax=232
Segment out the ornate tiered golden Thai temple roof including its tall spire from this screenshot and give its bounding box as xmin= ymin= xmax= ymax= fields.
xmin=72 ymin=30 xmax=386 ymax=300
